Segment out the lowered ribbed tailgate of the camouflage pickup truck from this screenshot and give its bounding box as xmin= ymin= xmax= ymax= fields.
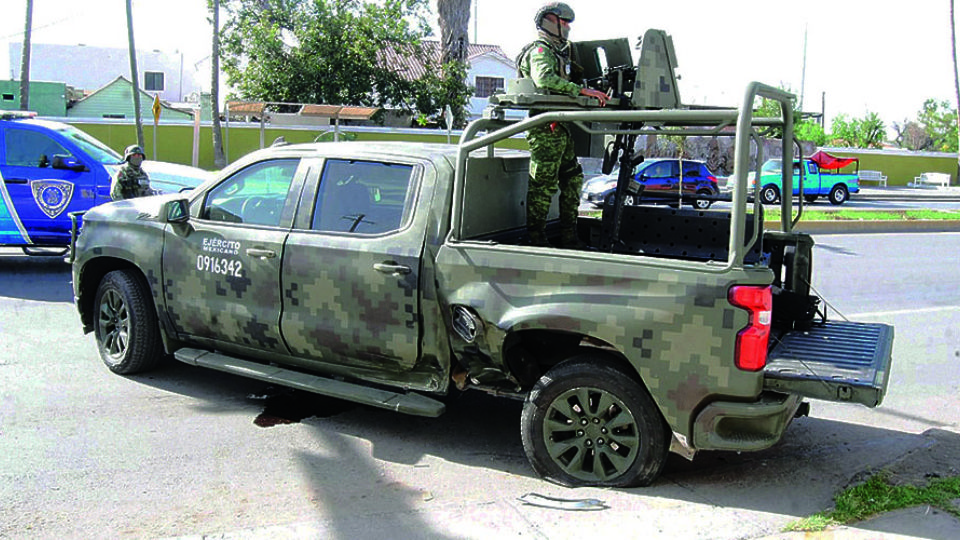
xmin=763 ymin=322 xmax=893 ymax=407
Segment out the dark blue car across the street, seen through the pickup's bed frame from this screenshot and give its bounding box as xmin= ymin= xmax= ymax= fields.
xmin=580 ymin=158 xmax=720 ymax=210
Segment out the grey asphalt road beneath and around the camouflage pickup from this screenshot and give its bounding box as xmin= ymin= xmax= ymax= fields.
xmin=0 ymin=233 xmax=960 ymax=539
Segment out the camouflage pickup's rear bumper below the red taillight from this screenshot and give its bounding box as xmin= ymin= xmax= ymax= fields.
xmin=693 ymin=392 xmax=803 ymax=452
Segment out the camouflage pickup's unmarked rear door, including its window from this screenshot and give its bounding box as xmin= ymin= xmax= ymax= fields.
xmin=281 ymin=159 xmax=429 ymax=371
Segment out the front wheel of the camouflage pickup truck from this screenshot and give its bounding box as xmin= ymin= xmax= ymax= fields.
xmin=93 ymin=270 xmax=163 ymax=375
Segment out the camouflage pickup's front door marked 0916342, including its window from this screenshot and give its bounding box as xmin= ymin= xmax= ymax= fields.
xmin=162 ymin=159 xmax=305 ymax=353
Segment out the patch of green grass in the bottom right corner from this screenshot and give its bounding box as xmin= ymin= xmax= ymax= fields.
xmin=784 ymin=473 xmax=960 ymax=531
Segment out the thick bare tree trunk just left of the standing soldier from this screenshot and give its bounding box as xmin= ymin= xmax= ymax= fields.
xmin=437 ymin=0 xmax=470 ymax=127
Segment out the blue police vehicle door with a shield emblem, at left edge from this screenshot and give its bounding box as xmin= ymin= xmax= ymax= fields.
xmin=0 ymin=126 xmax=96 ymax=246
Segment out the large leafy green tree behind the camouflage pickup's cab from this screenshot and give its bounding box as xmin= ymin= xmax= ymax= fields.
xmin=221 ymin=0 xmax=469 ymax=123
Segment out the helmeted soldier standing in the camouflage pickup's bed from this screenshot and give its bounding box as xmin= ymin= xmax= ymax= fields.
xmin=517 ymin=2 xmax=607 ymax=247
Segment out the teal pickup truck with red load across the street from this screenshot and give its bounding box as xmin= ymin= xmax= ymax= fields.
xmin=747 ymin=159 xmax=860 ymax=204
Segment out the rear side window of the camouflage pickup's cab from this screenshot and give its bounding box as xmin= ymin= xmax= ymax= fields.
xmin=311 ymin=159 xmax=413 ymax=234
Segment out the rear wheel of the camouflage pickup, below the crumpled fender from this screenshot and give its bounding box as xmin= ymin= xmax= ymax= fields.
xmin=520 ymin=355 xmax=670 ymax=487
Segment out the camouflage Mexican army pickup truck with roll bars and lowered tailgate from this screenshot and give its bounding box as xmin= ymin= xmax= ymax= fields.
xmin=72 ymin=34 xmax=893 ymax=486
